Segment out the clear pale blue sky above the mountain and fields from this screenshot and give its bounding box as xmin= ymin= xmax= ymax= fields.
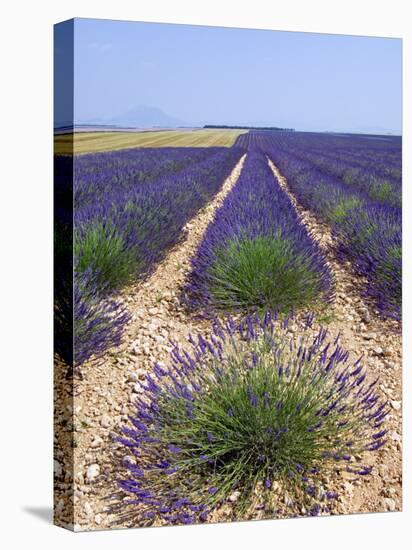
xmin=56 ymin=19 xmax=402 ymax=133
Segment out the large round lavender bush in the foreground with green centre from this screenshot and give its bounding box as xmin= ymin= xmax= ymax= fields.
xmin=118 ymin=313 xmax=387 ymax=525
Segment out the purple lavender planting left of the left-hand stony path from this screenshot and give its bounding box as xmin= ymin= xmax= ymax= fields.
xmin=56 ymin=148 xmax=242 ymax=365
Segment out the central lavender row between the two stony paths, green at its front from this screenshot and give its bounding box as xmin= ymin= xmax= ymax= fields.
xmin=186 ymin=151 xmax=332 ymax=312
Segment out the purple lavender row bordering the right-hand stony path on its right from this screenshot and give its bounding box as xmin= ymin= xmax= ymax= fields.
xmin=235 ymin=133 xmax=402 ymax=319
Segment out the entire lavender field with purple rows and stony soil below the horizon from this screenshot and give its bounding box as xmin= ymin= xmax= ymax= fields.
xmin=55 ymin=130 xmax=402 ymax=530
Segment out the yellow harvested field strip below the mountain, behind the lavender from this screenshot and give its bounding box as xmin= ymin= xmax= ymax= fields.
xmin=54 ymin=129 xmax=245 ymax=155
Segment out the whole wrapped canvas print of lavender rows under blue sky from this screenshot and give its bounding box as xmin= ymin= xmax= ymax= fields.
xmin=49 ymin=17 xmax=404 ymax=546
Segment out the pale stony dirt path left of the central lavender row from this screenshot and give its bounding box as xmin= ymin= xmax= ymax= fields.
xmin=56 ymin=155 xmax=246 ymax=531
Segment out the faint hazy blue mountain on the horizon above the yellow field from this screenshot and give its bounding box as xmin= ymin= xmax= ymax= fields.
xmin=105 ymin=105 xmax=188 ymax=128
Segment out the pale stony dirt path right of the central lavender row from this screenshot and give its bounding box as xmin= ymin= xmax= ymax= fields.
xmin=268 ymin=159 xmax=402 ymax=513
